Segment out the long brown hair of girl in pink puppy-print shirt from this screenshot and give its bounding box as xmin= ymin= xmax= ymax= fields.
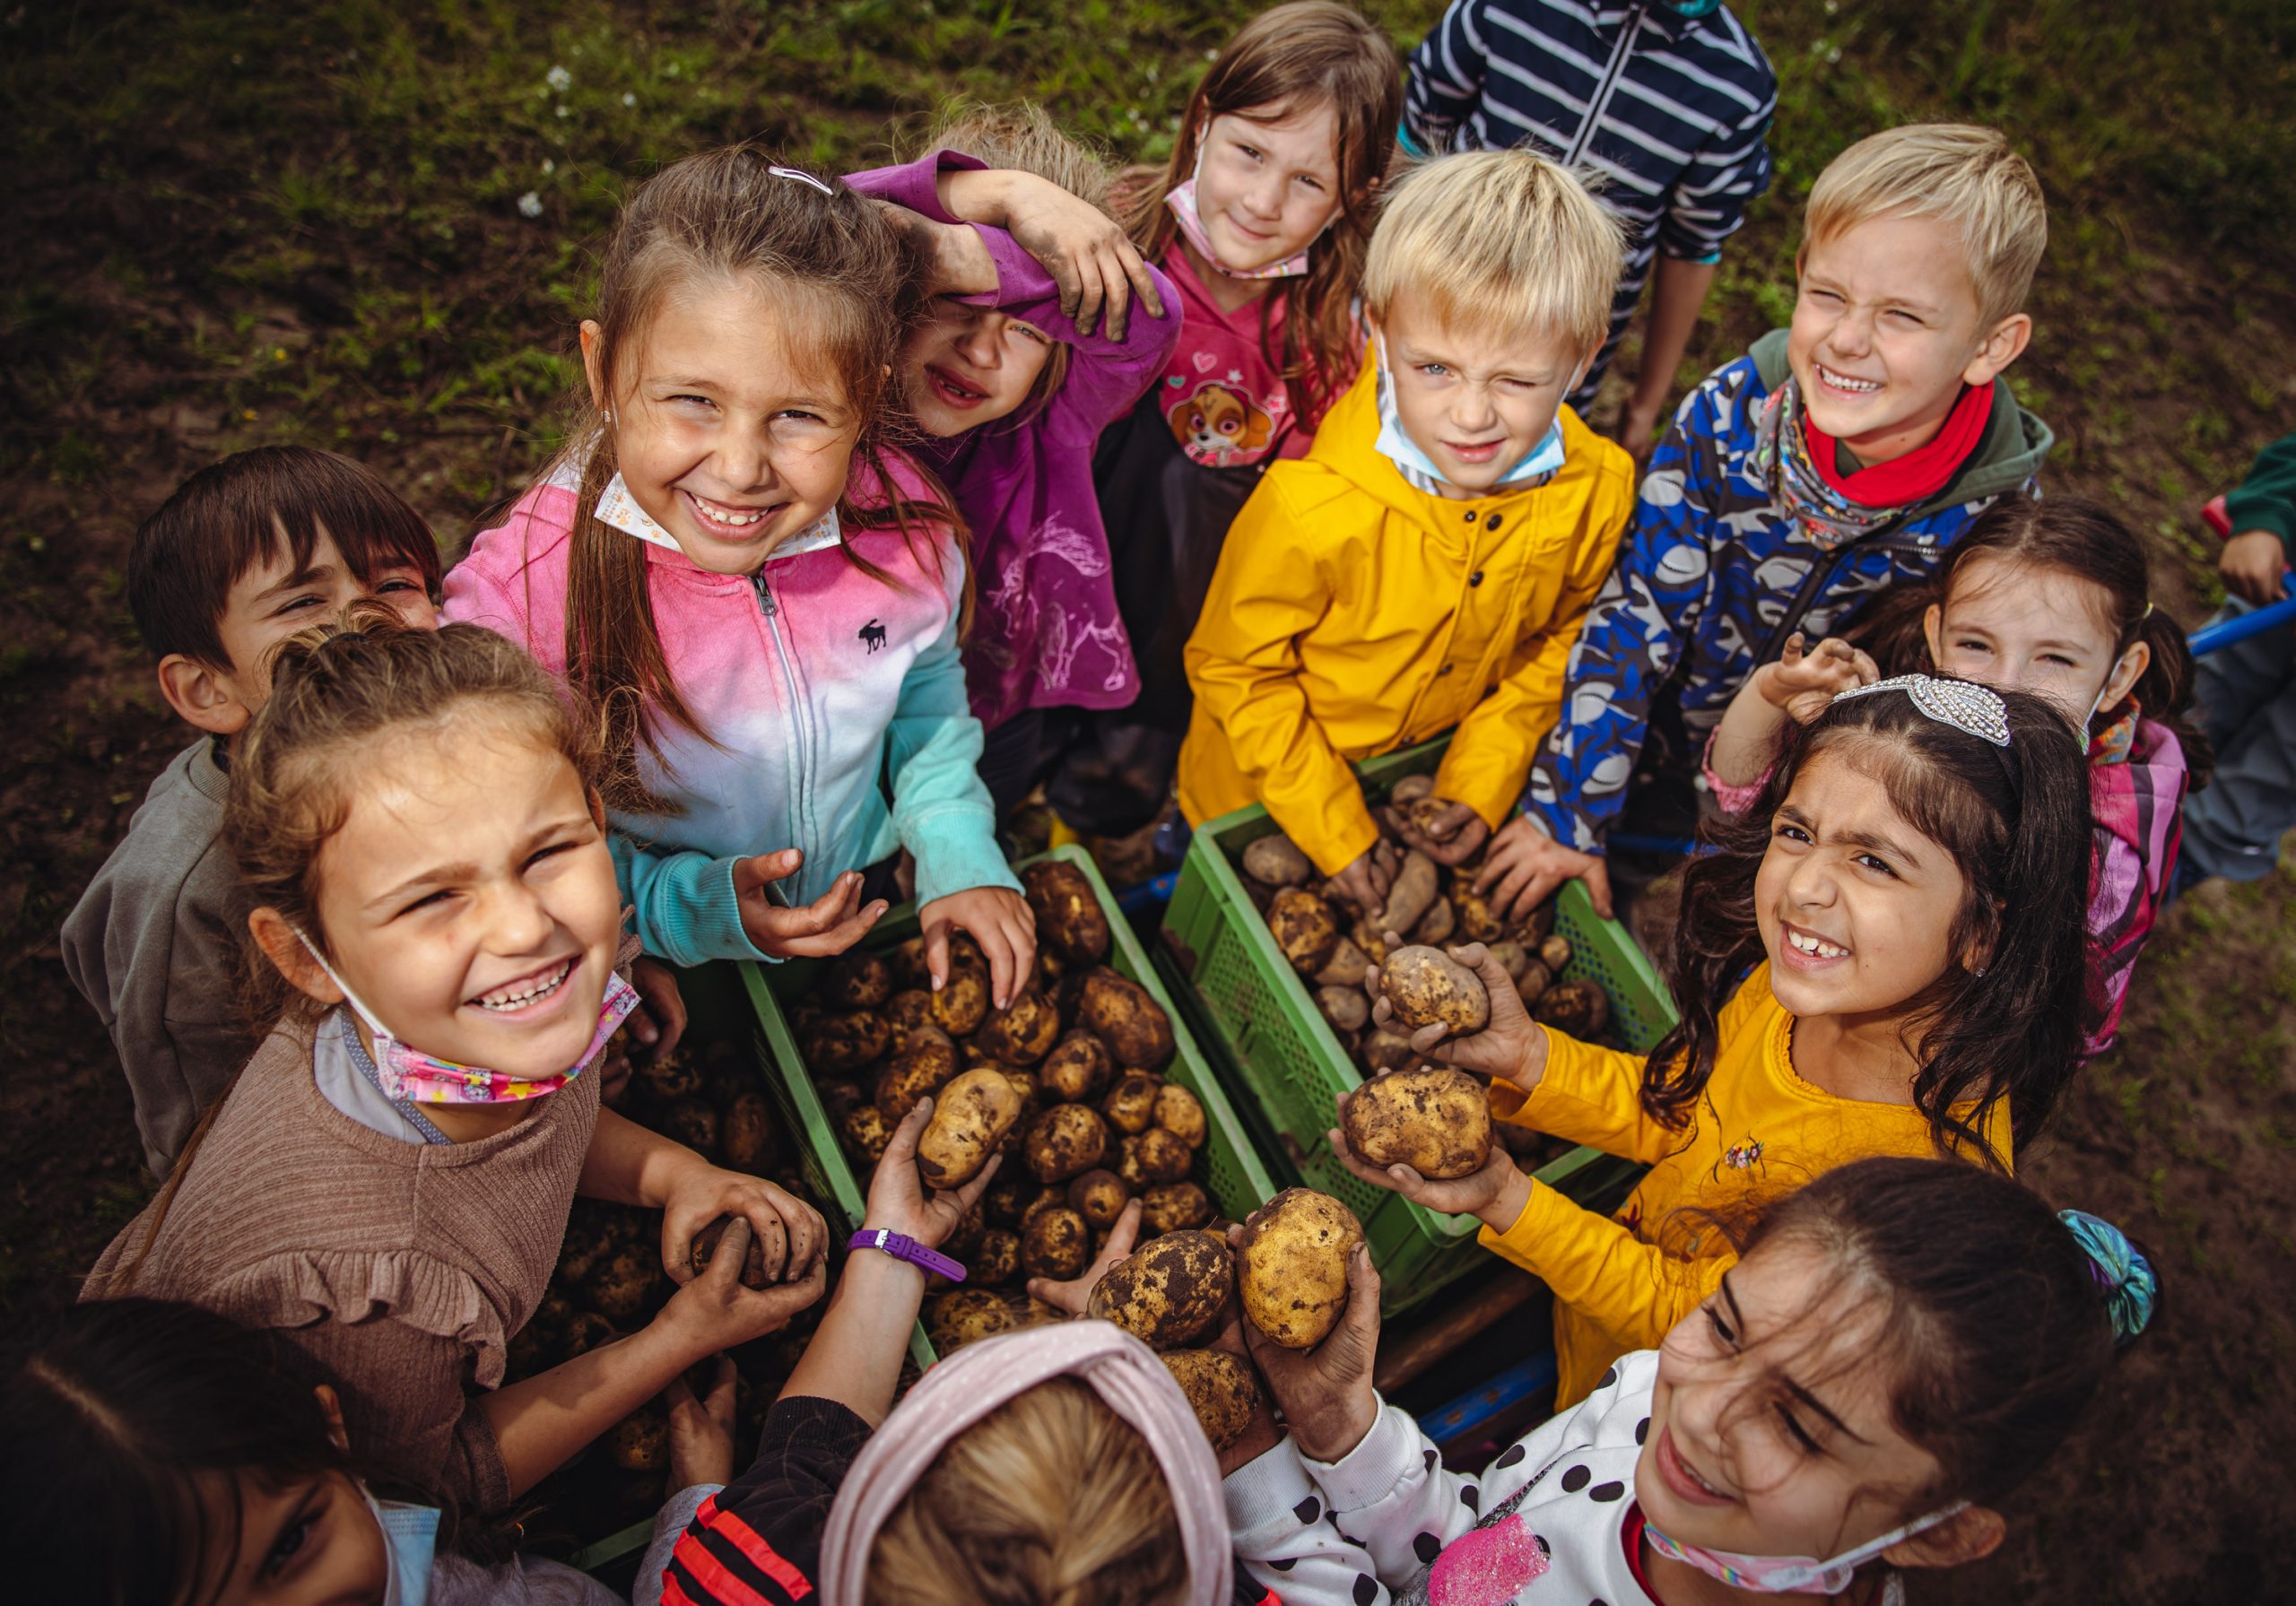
xmin=1123 ymin=0 xmax=1403 ymax=424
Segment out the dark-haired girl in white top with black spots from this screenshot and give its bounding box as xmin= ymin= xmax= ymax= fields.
xmin=1226 ymin=1159 xmax=2158 ymax=1606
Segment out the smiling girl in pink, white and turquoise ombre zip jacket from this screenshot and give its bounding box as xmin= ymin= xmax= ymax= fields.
xmin=446 ymin=147 xmax=1036 ymax=1003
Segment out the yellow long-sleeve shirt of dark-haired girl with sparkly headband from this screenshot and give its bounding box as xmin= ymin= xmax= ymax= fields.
xmin=1481 ymin=966 xmax=2009 ymax=1409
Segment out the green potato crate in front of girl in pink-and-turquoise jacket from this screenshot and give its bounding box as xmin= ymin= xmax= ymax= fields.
xmin=742 ymin=846 xmax=1276 ymax=1367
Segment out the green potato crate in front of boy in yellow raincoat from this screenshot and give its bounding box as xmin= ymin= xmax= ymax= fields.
xmin=1164 ymin=736 xmax=1674 ymax=1315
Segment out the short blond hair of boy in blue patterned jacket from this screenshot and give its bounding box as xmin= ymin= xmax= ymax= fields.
xmin=1803 ymin=122 xmax=2048 ymax=328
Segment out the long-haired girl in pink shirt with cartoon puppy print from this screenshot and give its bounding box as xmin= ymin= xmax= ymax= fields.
xmin=1047 ymin=0 xmax=1403 ymax=835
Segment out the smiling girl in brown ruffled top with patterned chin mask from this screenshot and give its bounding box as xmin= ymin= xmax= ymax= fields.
xmin=83 ymin=620 xmax=824 ymax=1512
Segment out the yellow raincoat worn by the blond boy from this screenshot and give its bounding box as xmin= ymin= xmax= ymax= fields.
xmin=1180 ymin=356 xmax=1635 ymax=874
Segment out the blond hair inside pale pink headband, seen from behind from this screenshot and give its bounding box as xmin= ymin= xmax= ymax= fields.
xmin=864 ymin=1376 xmax=1189 ymax=1606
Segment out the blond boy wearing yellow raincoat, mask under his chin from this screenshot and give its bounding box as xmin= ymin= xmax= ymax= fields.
xmin=1180 ymin=152 xmax=1632 ymax=907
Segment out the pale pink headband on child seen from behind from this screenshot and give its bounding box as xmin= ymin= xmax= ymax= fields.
xmin=822 ymin=1322 xmax=1233 ymax=1606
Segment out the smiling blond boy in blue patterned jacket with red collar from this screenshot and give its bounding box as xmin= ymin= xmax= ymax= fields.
xmin=1481 ymin=124 xmax=2053 ymax=913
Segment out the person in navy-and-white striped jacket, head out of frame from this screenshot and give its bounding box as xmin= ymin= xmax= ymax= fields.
xmin=1403 ymin=0 xmax=1777 ymax=406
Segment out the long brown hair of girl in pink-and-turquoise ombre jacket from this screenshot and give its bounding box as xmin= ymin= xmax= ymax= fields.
xmin=561 ymin=144 xmax=964 ymax=814
